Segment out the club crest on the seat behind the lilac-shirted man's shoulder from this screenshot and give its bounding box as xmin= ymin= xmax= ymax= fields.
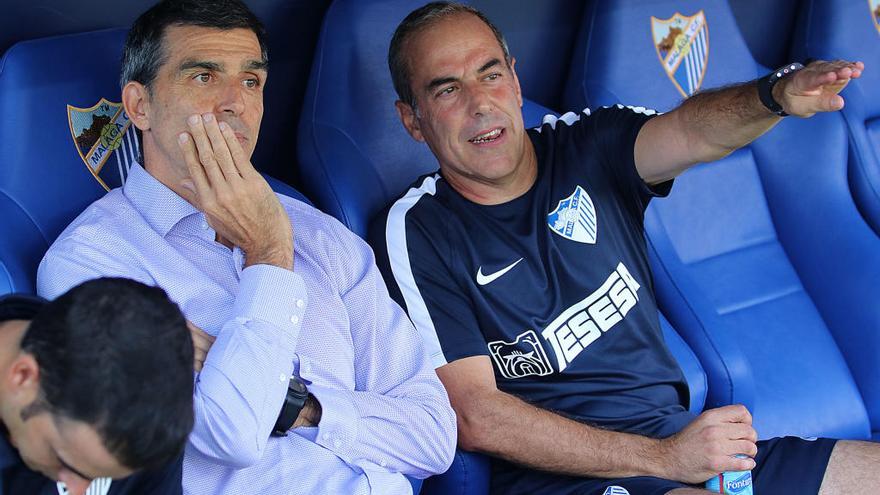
xmin=67 ymin=98 xmax=140 ymax=191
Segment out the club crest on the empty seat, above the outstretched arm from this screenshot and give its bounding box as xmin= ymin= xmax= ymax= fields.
xmin=651 ymin=10 xmax=709 ymax=98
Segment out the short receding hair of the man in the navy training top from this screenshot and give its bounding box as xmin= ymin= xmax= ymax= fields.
xmin=388 ymin=2 xmax=510 ymax=108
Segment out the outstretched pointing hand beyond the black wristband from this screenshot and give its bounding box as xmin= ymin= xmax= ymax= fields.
xmin=773 ymin=60 xmax=865 ymax=117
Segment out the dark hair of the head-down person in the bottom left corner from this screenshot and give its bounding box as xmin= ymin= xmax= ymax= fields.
xmin=21 ymin=278 xmax=193 ymax=469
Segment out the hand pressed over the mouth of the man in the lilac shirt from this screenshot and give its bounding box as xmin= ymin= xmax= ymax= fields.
xmin=178 ymin=113 xmax=293 ymax=270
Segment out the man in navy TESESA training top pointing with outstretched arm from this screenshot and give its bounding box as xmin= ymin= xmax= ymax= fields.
xmin=373 ymin=3 xmax=880 ymax=495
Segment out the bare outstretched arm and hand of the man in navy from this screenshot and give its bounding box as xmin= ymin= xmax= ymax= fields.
xmin=635 ymin=60 xmax=865 ymax=184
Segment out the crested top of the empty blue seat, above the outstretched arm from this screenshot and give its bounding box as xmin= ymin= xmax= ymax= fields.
xmin=565 ymin=0 xmax=759 ymax=111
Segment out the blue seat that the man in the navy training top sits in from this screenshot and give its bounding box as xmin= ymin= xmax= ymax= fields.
xmin=299 ymin=0 xmax=706 ymax=495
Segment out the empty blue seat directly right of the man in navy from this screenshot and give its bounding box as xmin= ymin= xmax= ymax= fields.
xmin=565 ymin=0 xmax=880 ymax=438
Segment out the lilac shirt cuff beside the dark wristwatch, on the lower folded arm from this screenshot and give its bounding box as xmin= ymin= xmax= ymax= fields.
xmin=309 ymin=384 xmax=360 ymax=461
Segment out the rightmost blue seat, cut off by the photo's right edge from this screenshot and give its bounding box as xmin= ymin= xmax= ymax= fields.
xmin=791 ymin=0 xmax=880 ymax=438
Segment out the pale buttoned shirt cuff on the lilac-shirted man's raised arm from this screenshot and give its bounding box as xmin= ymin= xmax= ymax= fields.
xmin=232 ymin=265 xmax=308 ymax=350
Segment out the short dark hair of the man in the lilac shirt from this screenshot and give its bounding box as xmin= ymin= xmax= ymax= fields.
xmin=119 ymin=0 xmax=269 ymax=91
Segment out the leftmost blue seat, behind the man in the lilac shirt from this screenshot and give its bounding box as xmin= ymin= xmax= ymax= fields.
xmin=0 ymin=29 xmax=303 ymax=294
